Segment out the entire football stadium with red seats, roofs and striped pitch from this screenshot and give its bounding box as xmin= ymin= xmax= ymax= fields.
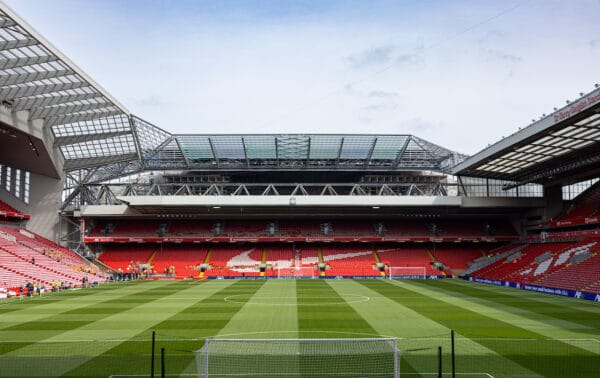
xmin=0 ymin=2 xmax=600 ymax=378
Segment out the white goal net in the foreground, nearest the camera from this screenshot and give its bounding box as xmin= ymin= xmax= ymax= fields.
xmin=196 ymin=338 xmax=400 ymax=378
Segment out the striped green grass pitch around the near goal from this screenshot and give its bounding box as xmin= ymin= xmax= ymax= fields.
xmin=0 ymin=280 xmax=600 ymax=378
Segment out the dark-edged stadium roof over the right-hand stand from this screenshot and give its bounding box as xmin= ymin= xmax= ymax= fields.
xmin=452 ymin=86 xmax=600 ymax=186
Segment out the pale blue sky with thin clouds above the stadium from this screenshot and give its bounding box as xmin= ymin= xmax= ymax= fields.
xmin=5 ymin=0 xmax=600 ymax=154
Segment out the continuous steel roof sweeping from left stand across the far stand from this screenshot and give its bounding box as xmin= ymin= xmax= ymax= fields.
xmin=0 ymin=2 xmax=466 ymax=183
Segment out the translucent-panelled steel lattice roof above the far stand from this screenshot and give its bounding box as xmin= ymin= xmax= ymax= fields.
xmin=133 ymin=117 xmax=464 ymax=171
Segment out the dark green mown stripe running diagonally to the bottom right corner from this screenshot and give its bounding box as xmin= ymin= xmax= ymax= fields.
xmin=366 ymin=281 xmax=600 ymax=377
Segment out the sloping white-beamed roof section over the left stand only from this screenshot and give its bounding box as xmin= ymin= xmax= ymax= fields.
xmin=0 ymin=2 xmax=137 ymax=170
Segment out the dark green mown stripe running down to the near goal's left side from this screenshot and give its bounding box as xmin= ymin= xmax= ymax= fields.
xmin=62 ymin=281 xmax=263 ymax=377
